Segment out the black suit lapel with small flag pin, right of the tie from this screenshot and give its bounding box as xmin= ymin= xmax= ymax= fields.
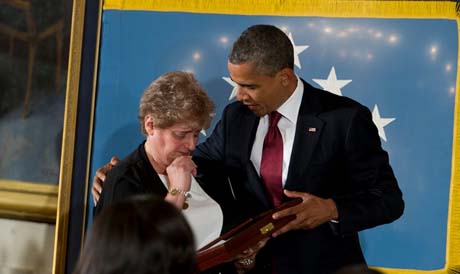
xmin=285 ymin=82 xmax=324 ymax=189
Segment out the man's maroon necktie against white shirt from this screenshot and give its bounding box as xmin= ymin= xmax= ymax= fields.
xmin=260 ymin=111 xmax=283 ymax=206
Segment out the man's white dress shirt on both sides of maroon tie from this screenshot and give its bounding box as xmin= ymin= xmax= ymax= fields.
xmin=251 ymin=76 xmax=303 ymax=187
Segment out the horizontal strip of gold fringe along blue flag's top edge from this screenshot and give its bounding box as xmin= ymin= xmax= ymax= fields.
xmin=104 ymin=0 xmax=459 ymax=19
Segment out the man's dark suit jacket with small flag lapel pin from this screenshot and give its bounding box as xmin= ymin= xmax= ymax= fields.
xmin=194 ymin=82 xmax=404 ymax=274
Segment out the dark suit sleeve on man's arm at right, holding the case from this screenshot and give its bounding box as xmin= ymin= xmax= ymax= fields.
xmin=334 ymin=107 xmax=404 ymax=234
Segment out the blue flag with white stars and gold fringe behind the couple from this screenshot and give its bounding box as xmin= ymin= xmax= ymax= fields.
xmin=58 ymin=0 xmax=460 ymax=273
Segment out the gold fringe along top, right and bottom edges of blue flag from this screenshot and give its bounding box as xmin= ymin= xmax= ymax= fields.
xmin=103 ymin=0 xmax=460 ymax=274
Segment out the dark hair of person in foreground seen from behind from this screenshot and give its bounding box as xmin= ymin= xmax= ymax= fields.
xmin=74 ymin=195 xmax=195 ymax=274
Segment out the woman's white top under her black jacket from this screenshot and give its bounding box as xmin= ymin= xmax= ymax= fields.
xmin=158 ymin=174 xmax=224 ymax=249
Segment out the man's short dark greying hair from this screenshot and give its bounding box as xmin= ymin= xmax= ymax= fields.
xmin=228 ymin=25 xmax=294 ymax=76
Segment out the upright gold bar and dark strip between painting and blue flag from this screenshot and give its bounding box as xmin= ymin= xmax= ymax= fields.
xmin=53 ymin=0 xmax=103 ymax=274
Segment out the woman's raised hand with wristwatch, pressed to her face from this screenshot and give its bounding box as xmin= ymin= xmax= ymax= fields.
xmin=165 ymin=156 xmax=197 ymax=209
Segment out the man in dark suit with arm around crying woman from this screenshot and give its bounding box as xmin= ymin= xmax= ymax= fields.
xmin=193 ymin=25 xmax=404 ymax=274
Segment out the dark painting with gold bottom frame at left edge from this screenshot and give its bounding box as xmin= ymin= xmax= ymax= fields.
xmin=0 ymin=0 xmax=76 ymax=223
